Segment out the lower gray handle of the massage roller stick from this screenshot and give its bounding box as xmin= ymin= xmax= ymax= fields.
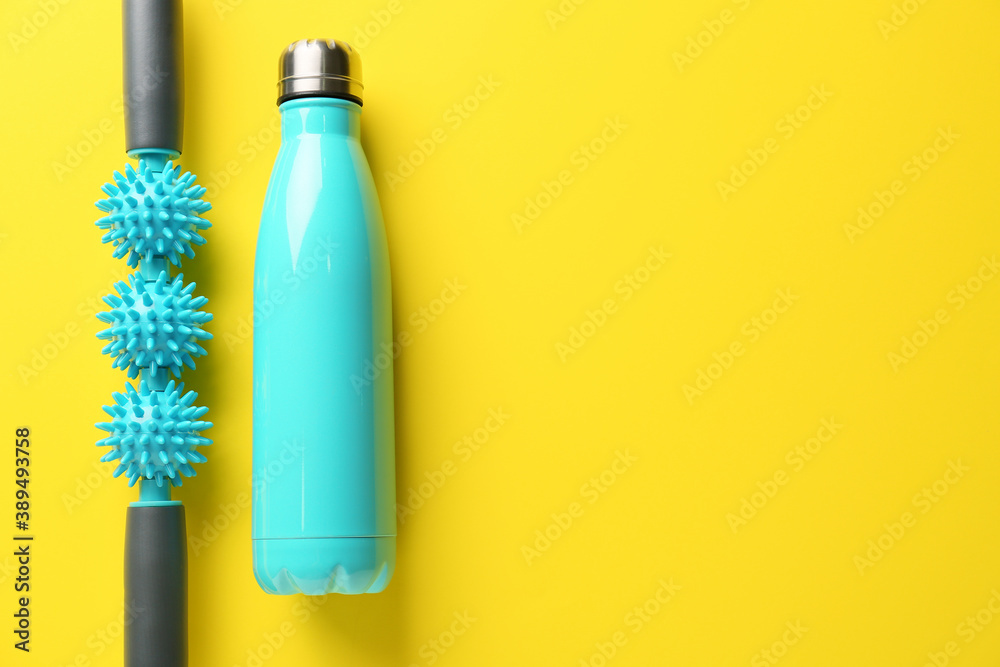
xmin=125 ymin=505 xmax=188 ymax=667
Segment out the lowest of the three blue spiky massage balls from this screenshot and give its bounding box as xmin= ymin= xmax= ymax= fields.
xmin=95 ymin=380 xmax=212 ymax=486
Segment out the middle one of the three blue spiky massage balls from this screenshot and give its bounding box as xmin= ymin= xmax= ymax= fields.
xmin=97 ymin=271 xmax=212 ymax=378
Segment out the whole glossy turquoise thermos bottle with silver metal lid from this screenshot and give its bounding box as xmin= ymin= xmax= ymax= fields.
xmin=252 ymin=39 xmax=396 ymax=595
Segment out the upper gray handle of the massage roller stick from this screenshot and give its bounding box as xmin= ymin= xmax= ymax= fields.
xmin=122 ymin=0 xmax=184 ymax=155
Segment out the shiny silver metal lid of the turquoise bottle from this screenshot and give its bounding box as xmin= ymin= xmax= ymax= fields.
xmin=278 ymin=39 xmax=364 ymax=104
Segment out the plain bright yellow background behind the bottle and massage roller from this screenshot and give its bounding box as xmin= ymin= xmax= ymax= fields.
xmin=0 ymin=0 xmax=1000 ymax=667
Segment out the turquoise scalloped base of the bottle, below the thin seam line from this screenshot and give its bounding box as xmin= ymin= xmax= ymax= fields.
xmin=253 ymin=535 xmax=396 ymax=595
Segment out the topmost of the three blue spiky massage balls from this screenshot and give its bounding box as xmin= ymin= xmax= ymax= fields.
xmin=94 ymin=160 xmax=212 ymax=268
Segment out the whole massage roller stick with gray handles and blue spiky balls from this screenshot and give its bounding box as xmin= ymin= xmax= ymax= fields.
xmin=96 ymin=0 xmax=212 ymax=667
